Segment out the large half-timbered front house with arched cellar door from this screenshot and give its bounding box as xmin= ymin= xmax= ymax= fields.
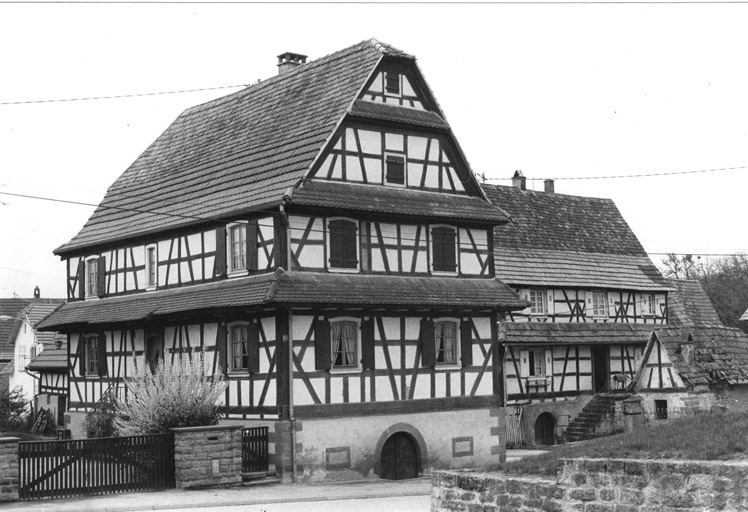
xmin=35 ymin=40 xmax=526 ymax=478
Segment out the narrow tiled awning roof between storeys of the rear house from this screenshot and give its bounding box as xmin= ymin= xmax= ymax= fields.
xmin=506 ymin=322 xmax=652 ymax=345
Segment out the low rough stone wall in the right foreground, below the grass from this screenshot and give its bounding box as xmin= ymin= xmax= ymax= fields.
xmin=431 ymin=459 xmax=748 ymax=512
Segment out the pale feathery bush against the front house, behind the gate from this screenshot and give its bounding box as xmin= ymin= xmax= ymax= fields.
xmin=114 ymin=353 xmax=226 ymax=435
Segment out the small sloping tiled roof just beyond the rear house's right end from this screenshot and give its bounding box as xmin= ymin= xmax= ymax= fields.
xmin=667 ymin=279 xmax=724 ymax=327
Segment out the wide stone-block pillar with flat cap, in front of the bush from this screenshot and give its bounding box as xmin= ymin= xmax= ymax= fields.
xmin=171 ymin=425 xmax=242 ymax=489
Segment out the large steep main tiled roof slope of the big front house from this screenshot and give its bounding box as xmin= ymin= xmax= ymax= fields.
xmin=55 ymin=40 xmax=392 ymax=254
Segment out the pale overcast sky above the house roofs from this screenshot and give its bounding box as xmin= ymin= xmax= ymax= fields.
xmin=0 ymin=3 xmax=748 ymax=297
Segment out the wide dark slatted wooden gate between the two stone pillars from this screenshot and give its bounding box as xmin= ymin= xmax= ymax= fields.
xmin=18 ymin=434 xmax=174 ymax=500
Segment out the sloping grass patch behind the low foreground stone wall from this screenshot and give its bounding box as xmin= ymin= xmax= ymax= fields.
xmin=502 ymin=413 xmax=748 ymax=476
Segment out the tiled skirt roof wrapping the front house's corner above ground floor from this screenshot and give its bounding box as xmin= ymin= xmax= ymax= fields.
xmin=37 ymin=270 xmax=527 ymax=330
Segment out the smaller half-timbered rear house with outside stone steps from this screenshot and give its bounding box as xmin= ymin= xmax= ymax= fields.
xmin=483 ymin=172 xmax=671 ymax=445
